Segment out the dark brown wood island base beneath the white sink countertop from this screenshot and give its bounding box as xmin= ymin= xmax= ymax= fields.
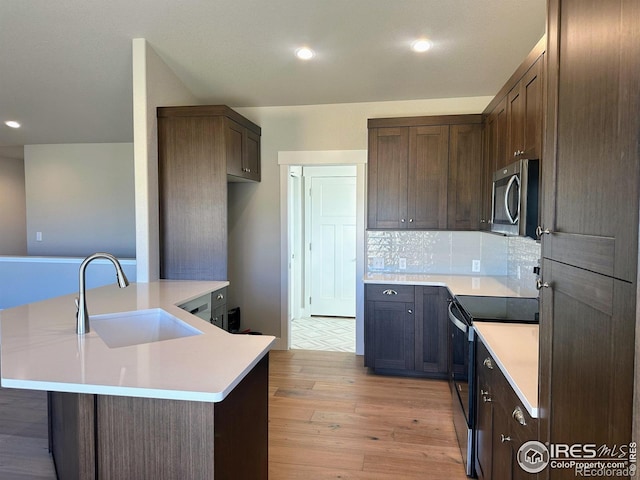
xmin=49 ymin=354 xmax=269 ymax=480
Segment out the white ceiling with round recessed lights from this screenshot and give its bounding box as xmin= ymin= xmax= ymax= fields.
xmin=0 ymin=0 xmax=546 ymax=155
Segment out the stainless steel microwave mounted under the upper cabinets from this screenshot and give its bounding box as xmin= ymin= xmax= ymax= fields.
xmin=491 ymin=159 xmax=540 ymax=238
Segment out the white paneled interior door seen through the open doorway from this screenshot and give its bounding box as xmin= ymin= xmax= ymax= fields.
xmin=309 ymin=176 xmax=356 ymax=317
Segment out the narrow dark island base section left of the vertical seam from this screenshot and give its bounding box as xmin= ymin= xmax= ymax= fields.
xmin=48 ymin=392 xmax=96 ymax=480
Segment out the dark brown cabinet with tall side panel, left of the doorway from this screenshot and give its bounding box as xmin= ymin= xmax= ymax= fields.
xmin=157 ymin=105 xmax=260 ymax=280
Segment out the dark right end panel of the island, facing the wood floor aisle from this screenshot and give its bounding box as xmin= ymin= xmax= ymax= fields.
xmin=215 ymin=353 xmax=269 ymax=480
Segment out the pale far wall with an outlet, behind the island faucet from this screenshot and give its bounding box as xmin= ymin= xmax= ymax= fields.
xmin=24 ymin=143 xmax=136 ymax=258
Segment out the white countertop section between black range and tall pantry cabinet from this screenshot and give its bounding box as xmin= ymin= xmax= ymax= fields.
xmin=473 ymin=322 xmax=539 ymax=418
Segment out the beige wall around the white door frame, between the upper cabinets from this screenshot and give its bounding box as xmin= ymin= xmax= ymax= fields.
xmin=229 ymin=97 xmax=492 ymax=337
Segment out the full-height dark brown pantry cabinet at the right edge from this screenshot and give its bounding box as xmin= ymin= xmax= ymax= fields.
xmin=539 ymin=0 xmax=640 ymax=479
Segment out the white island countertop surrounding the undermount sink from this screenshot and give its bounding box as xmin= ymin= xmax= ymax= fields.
xmin=0 ymin=280 xmax=275 ymax=402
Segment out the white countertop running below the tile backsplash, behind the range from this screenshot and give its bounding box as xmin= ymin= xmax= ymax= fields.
xmin=363 ymin=273 xmax=538 ymax=297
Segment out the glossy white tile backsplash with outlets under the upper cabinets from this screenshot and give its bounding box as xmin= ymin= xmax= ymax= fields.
xmin=367 ymin=230 xmax=540 ymax=281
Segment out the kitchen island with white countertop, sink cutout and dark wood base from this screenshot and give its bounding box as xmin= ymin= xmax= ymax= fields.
xmin=0 ymin=281 xmax=274 ymax=479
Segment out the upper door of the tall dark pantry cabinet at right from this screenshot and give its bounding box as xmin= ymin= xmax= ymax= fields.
xmin=542 ymin=0 xmax=640 ymax=282
